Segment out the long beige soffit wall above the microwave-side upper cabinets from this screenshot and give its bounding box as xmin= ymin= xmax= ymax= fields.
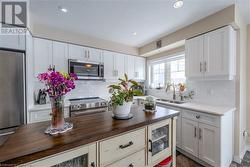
xmin=30 ymin=23 xmax=138 ymax=55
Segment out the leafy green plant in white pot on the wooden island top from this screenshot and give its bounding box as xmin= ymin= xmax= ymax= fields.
xmin=108 ymin=74 xmax=143 ymax=118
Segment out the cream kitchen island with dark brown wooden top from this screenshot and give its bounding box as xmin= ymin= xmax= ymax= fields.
xmin=0 ymin=106 xmax=179 ymax=167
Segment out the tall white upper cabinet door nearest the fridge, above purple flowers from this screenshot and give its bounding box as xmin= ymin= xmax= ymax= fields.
xmin=33 ymin=38 xmax=52 ymax=77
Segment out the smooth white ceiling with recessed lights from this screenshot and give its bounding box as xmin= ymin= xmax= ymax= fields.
xmin=30 ymin=0 xmax=234 ymax=47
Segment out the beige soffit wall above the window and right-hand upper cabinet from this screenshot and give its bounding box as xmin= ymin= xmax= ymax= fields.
xmin=139 ymin=5 xmax=235 ymax=55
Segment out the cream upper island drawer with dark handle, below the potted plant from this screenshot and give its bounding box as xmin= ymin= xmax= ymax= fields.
xmin=100 ymin=128 xmax=146 ymax=166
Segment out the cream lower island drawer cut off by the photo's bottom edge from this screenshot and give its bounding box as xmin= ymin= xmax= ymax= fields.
xmin=107 ymin=149 xmax=146 ymax=167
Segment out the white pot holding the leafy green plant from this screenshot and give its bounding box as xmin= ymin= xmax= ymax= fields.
xmin=113 ymin=102 xmax=133 ymax=118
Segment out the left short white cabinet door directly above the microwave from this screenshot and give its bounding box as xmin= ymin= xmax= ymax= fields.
xmin=68 ymin=44 xmax=87 ymax=61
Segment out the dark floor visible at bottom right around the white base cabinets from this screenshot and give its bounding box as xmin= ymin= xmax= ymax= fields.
xmin=176 ymin=152 xmax=250 ymax=167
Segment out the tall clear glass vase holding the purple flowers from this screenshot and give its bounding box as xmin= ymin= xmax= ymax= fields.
xmin=50 ymin=96 xmax=65 ymax=130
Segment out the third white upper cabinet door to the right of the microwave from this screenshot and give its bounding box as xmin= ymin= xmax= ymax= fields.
xmin=124 ymin=55 xmax=135 ymax=79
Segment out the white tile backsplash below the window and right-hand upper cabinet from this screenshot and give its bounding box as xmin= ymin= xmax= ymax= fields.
xmin=147 ymin=81 xmax=235 ymax=107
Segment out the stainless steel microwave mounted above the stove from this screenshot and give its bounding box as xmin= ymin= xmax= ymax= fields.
xmin=68 ymin=59 xmax=104 ymax=80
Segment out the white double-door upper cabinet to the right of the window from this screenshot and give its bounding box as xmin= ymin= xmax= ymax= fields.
xmin=185 ymin=26 xmax=236 ymax=80
